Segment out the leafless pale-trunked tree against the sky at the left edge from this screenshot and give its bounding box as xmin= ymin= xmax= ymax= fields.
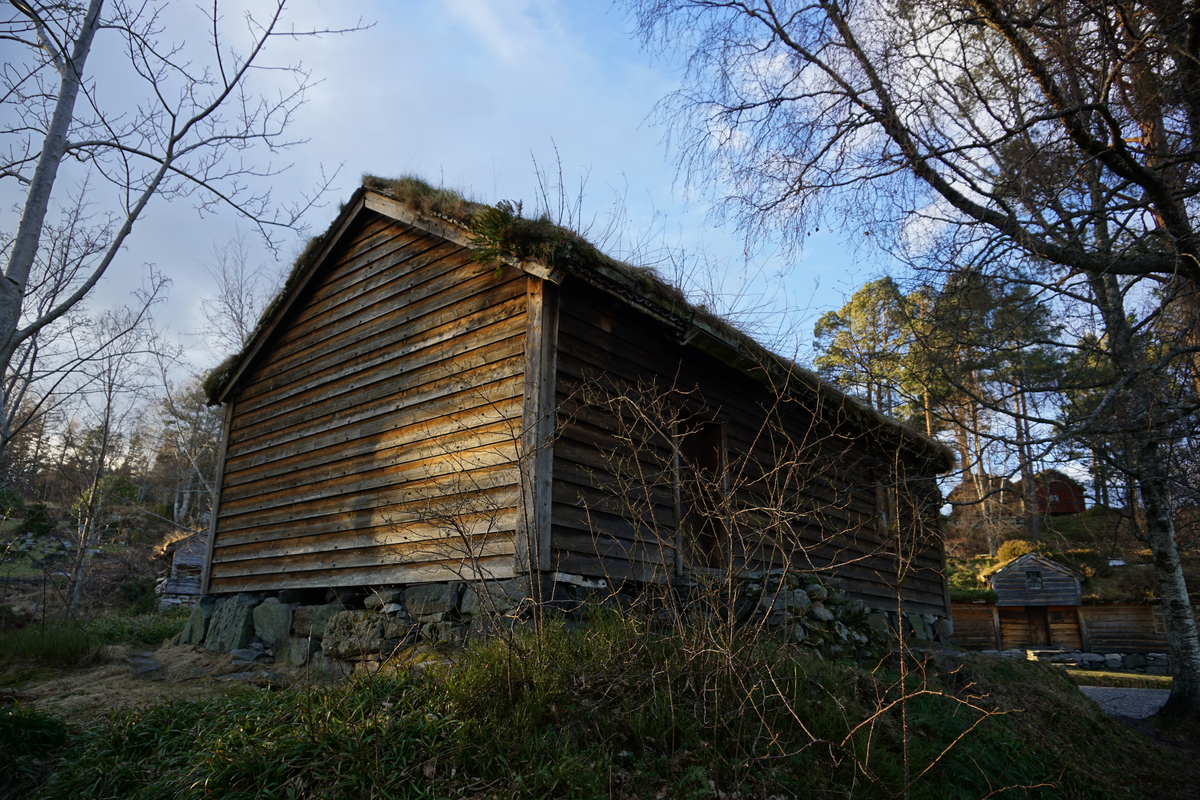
xmin=0 ymin=0 xmax=361 ymax=465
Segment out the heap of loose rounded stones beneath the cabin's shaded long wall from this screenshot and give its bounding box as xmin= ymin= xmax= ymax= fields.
xmin=736 ymin=569 xmax=888 ymax=658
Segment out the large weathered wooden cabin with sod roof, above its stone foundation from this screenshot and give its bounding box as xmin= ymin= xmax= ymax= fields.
xmin=205 ymin=179 xmax=953 ymax=616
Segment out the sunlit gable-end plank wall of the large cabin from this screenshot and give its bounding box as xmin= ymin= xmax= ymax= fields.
xmin=210 ymin=211 xmax=527 ymax=593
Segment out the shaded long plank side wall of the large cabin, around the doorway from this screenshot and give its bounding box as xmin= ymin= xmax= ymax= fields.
xmin=551 ymin=281 xmax=948 ymax=615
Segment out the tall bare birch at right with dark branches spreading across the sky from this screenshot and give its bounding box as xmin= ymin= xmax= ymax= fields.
xmin=631 ymin=0 xmax=1200 ymax=715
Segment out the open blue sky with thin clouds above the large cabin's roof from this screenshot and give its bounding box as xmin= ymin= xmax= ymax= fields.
xmin=0 ymin=0 xmax=880 ymax=369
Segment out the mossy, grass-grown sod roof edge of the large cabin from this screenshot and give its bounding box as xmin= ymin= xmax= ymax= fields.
xmin=204 ymin=175 xmax=954 ymax=471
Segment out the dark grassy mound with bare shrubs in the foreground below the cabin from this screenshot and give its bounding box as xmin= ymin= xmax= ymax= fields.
xmin=14 ymin=618 xmax=1184 ymax=800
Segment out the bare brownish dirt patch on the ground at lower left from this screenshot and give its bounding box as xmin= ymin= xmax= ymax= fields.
xmin=0 ymin=645 xmax=304 ymax=724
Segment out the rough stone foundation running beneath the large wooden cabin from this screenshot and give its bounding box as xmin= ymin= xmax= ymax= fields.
xmin=179 ymin=570 xmax=950 ymax=675
